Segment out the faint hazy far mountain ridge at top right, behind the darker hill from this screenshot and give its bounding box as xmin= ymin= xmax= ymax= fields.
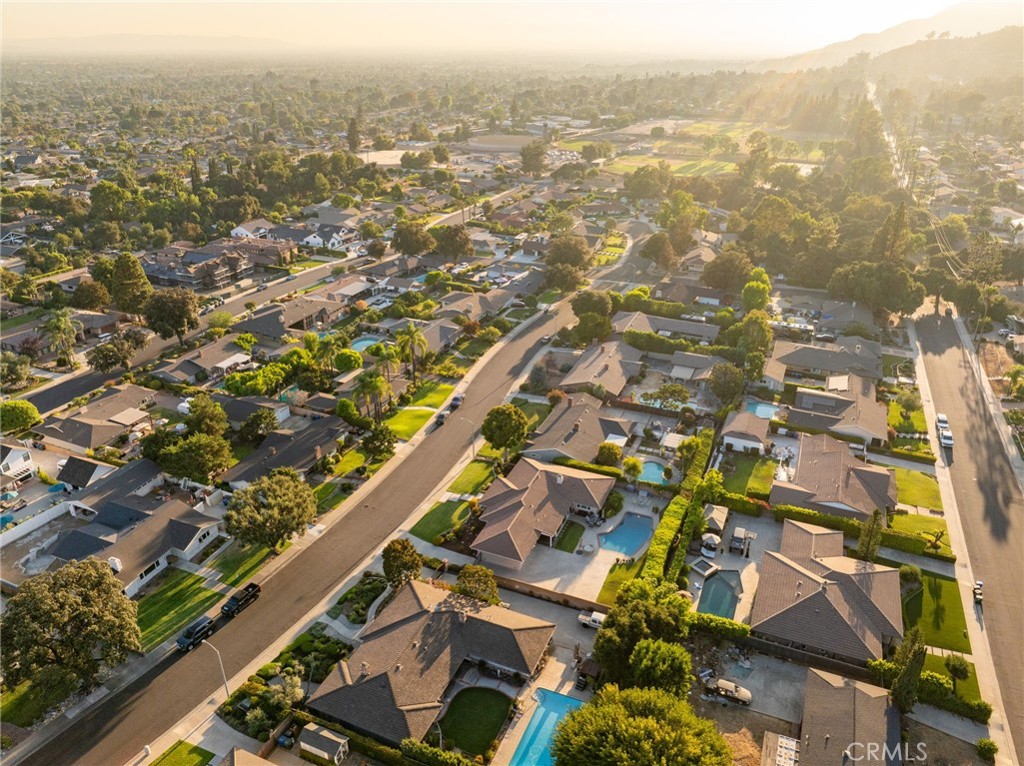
xmin=750 ymin=2 xmax=1024 ymax=72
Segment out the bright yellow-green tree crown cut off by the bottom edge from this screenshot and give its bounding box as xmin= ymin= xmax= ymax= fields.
xmin=551 ymin=684 xmax=732 ymax=766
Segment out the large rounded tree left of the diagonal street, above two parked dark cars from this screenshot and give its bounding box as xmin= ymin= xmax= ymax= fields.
xmin=224 ymin=468 xmax=316 ymax=550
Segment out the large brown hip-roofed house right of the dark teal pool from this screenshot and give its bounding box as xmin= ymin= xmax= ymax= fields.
xmin=751 ymin=519 xmax=903 ymax=665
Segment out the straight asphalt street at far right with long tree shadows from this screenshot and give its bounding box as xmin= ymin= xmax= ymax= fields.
xmin=915 ymin=314 xmax=1024 ymax=753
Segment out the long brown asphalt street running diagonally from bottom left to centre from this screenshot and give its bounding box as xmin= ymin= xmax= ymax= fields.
xmin=23 ymin=303 xmax=570 ymax=766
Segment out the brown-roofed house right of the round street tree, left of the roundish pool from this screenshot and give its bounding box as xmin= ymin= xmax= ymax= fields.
xmin=522 ymin=393 xmax=634 ymax=463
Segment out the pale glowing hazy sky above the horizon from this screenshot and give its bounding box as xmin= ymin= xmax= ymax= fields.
xmin=0 ymin=0 xmax=1011 ymax=58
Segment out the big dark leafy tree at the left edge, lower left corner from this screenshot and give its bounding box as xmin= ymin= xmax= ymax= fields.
xmin=0 ymin=558 xmax=142 ymax=687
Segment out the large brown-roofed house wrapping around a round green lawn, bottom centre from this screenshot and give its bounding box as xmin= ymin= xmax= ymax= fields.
xmin=309 ymin=580 xmax=555 ymax=744
